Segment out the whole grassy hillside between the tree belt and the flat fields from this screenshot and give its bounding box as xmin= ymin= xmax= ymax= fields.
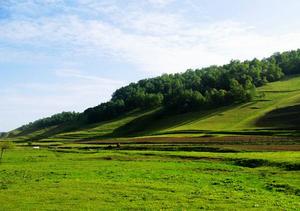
xmin=4 ymin=76 xmax=300 ymax=145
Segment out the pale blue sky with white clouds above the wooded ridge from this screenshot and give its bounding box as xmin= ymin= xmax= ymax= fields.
xmin=0 ymin=0 xmax=300 ymax=131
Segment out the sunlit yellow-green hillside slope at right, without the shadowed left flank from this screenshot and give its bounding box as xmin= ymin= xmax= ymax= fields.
xmin=159 ymin=76 xmax=300 ymax=132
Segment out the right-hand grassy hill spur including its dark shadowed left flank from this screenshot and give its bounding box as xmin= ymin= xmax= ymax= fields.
xmin=95 ymin=76 xmax=300 ymax=136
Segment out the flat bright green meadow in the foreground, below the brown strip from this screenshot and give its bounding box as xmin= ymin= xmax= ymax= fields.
xmin=0 ymin=148 xmax=300 ymax=210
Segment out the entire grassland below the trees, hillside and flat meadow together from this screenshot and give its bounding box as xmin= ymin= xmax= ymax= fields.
xmin=0 ymin=76 xmax=300 ymax=210
